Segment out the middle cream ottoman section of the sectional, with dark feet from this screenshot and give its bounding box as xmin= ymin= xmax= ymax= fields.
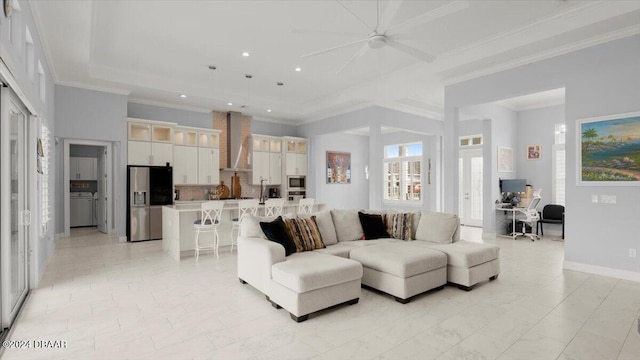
xmin=349 ymin=244 xmax=447 ymax=304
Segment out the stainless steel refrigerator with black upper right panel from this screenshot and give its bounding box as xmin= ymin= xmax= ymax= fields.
xmin=127 ymin=166 xmax=173 ymax=241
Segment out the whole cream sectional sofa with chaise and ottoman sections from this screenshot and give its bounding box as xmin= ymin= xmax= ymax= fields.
xmin=238 ymin=209 xmax=500 ymax=322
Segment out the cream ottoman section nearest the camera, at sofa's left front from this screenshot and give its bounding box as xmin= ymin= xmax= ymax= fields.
xmin=269 ymin=251 xmax=362 ymax=322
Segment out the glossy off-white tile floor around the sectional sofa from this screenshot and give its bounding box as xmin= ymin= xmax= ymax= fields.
xmin=2 ymin=228 xmax=640 ymax=360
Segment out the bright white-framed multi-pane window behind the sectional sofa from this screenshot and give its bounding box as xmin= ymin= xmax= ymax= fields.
xmin=383 ymin=143 xmax=422 ymax=204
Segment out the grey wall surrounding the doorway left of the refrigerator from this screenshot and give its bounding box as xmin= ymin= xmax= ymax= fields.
xmin=54 ymin=85 xmax=127 ymax=236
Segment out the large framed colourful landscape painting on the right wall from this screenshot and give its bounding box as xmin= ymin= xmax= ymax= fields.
xmin=576 ymin=112 xmax=640 ymax=186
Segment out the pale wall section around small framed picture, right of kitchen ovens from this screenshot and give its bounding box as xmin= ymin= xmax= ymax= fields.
xmin=308 ymin=134 xmax=369 ymax=209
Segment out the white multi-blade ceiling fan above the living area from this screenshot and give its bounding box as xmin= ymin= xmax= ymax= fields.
xmin=293 ymin=0 xmax=469 ymax=74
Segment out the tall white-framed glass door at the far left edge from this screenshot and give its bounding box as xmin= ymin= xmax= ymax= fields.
xmin=0 ymin=88 xmax=31 ymax=328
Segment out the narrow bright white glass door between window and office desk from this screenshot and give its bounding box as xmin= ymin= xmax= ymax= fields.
xmin=458 ymin=149 xmax=483 ymax=226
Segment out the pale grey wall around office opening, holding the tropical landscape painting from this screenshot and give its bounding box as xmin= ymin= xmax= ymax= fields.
xmin=444 ymin=35 xmax=640 ymax=279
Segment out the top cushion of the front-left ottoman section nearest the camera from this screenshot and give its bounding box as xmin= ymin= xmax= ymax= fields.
xmin=271 ymin=251 xmax=362 ymax=293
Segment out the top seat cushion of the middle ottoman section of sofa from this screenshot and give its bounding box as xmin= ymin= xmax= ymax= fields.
xmin=349 ymin=244 xmax=447 ymax=278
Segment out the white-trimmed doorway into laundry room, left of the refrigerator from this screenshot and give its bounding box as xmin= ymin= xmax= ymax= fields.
xmin=64 ymin=139 xmax=115 ymax=236
